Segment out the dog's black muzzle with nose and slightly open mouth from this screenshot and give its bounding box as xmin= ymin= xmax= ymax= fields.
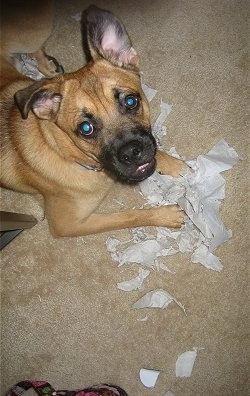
xmin=102 ymin=128 xmax=156 ymax=183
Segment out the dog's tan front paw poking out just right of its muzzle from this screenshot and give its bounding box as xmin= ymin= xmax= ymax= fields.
xmin=156 ymin=150 xmax=188 ymax=177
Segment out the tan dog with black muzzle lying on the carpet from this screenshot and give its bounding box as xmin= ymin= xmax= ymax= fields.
xmin=1 ymin=6 xmax=185 ymax=236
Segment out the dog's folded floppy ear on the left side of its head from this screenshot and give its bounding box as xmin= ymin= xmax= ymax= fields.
xmin=14 ymin=82 xmax=62 ymax=120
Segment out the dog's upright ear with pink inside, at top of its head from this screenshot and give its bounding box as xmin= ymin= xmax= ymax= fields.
xmin=82 ymin=5 xmax=139 ymax=70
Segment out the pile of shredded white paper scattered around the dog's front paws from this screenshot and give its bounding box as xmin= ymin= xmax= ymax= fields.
xmin=106 ymin=85 xmax=239 ymax=309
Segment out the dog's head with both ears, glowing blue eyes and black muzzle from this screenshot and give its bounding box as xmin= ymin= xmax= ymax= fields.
xmin=15 ymin=6 xmax=156 ymax=182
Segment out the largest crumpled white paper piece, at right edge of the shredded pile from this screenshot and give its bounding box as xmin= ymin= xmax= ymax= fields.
xmin=178 ymin=139 xmax=239 ymax=252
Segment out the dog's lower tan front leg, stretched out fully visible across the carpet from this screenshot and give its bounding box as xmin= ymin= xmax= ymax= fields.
xmin=45 ymin=197 xmax=185 ymax=237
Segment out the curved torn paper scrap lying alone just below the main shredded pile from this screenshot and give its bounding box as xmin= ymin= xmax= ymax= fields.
xmin=133 ymin=289 xmax=186 ymax=313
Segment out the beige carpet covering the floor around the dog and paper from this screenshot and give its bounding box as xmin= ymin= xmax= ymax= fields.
xmin=1 ymin=0 xmax=249 ymax=396
